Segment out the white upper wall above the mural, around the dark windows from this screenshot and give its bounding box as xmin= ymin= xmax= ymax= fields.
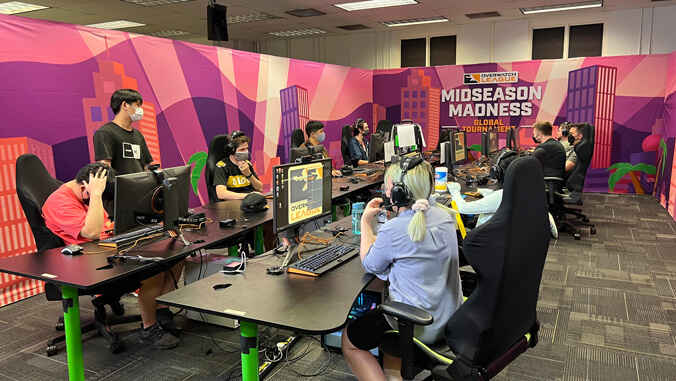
xmin=257 ymin=6 xmax=676 ymax=69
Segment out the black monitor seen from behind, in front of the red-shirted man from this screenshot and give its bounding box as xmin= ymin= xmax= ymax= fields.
xmin=114 ymin=165 xmax=191 ymax=234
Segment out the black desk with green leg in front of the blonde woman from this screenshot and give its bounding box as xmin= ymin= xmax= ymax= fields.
xmin=157 ymin=220 xmax=375 ymax=381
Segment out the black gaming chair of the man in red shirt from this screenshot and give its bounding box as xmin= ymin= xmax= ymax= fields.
xmin=16 ymin=154 xmax=141 ymax=356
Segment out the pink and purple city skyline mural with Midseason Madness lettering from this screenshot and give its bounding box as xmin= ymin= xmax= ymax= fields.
xmin=0 ymin=15 xmax=676 ymax=306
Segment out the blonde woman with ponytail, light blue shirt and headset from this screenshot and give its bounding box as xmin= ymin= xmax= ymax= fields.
xmin=342 ymin=159 xmax=462 ymax=380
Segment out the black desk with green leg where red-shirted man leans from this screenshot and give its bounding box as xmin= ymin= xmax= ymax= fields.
xmin=0 ymin=200 xmax=272 ymax=380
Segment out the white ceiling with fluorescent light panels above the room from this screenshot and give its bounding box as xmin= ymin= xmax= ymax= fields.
xmin=9 ymin=0 xmax=676 ymax=45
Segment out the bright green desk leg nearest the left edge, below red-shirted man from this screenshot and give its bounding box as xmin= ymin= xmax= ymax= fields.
xmin=61 ymin=286 xmax=84 ymax=381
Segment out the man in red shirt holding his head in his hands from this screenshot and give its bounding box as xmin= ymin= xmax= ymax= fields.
xmin=42 ymin=163 xmax=184 ymax=349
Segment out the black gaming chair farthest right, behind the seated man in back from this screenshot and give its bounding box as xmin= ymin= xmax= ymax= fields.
xmin=550 ymin=123 xmax=596 ymax=240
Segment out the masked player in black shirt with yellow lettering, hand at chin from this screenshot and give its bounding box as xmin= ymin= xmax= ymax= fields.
xmin=214 ymin=131 xmax=263 ymax=200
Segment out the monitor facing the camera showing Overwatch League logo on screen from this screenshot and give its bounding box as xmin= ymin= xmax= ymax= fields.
xmin=272 ymin=159 xmax=332 ymax=234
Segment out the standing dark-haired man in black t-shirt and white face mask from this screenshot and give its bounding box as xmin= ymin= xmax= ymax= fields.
xmin=94 ymin=89 xmax=153 ymax=175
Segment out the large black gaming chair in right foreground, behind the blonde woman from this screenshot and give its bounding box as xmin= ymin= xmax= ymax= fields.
xmin=378 ymin=157 xmax=550 ymax=380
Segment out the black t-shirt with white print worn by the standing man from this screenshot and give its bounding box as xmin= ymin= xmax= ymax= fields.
xmin=94 ymin=122 xmax=153 ymax=175
